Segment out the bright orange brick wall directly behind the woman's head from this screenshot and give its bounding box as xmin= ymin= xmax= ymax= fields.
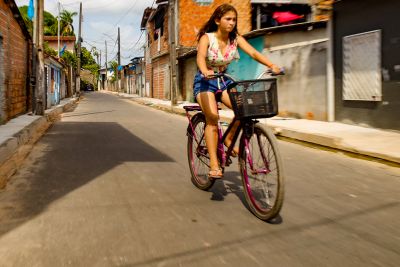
xmin=179 ymin=0 xmax=251 ymax=46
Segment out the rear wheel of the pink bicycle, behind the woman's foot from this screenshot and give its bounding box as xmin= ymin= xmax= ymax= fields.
xmin=187 ymin=113 xmax=215 ymax=190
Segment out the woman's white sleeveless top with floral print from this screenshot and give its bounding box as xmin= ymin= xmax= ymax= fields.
xmin=206 ymin=32 xmax=240 ymax=72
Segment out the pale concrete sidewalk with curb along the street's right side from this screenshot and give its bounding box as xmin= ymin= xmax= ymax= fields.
xmin=111 ymin=91 xmax=400 ymax=166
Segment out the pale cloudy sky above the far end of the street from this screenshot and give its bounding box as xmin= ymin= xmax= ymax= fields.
xmin=15 ymin=0 xmax=156 ymax=66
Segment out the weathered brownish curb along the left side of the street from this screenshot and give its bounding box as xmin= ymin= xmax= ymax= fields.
xmin=0 ymin=97 xmax=79 ymax=189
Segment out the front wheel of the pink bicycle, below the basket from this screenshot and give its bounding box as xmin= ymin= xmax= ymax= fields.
xmin=239 ymin=124 xmax=284 ymax=220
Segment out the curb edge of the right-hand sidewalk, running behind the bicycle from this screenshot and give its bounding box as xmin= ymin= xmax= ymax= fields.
xmin=112 ymin=92 xmax=400 ymax=164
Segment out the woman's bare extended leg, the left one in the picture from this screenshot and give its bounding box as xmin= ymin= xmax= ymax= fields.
xmin=196 ymin=92 xmax=219 ymax=170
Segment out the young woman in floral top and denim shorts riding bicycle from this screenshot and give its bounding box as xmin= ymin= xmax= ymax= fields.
xmin=193 ymin=4 xmax=280 ymax=179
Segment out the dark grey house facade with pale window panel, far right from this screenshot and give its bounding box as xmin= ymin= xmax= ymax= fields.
xmin=332 ymin=0 xmax=400 ymax=130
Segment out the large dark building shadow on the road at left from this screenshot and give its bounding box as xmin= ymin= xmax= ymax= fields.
xmin=0 ymin=122 xmax=174 ymax=236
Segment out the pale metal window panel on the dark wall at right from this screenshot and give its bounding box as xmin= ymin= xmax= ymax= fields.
xmin=343 ymin=30 xmax=382 ymax=101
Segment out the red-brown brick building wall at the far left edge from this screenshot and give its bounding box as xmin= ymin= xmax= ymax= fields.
xmin=0 ymin=0 xmax=31 ymax=124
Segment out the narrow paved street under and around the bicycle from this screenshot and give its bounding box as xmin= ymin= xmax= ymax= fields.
xmin=0 ymin=92 xmax=400 ymax=267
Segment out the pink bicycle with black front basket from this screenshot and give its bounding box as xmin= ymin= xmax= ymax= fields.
xmin=184 ymin=72 xmax=284 ymax=220
